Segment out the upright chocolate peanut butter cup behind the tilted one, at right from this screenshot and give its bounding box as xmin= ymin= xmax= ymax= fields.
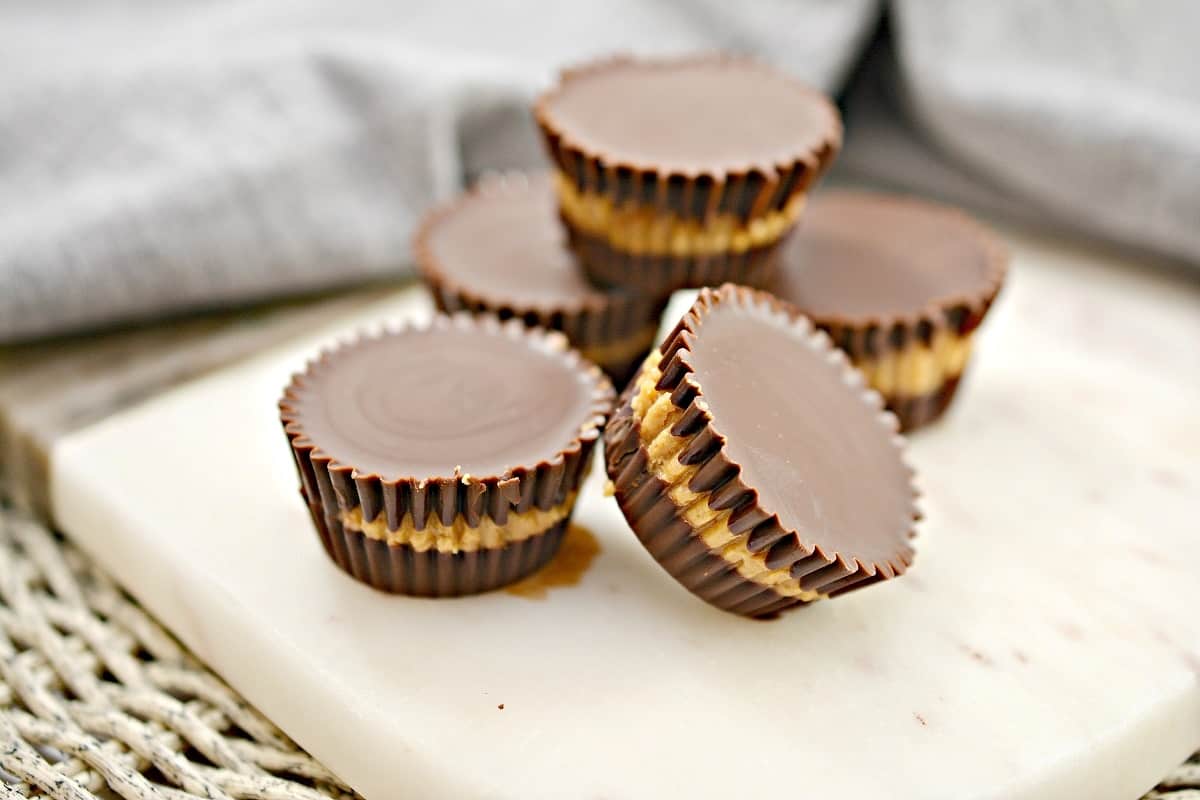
xmin=772 ymin=191 xmax=1008 ymax=431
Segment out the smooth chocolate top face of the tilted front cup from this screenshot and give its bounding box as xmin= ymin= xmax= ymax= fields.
xmin=690 ymin=287 xmax=914 ymax=564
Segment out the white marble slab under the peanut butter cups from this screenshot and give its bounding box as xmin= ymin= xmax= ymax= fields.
xmin=50 ymin=231 xmax=1200 ymax=800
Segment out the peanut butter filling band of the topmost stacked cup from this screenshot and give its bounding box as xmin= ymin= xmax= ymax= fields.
xmin=554 ymin=172 xmax=805 ymax=257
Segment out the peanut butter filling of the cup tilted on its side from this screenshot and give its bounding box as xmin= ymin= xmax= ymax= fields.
xmin=632 ymin=353 xmax=824 ymax=601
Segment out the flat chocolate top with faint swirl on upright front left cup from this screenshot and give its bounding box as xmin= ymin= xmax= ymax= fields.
xmin=289 ymin=317 xmax=612 ymax=480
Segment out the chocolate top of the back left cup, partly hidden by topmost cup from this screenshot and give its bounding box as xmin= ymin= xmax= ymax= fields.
xmin=418 ymin=175 xmax=607 ymax=308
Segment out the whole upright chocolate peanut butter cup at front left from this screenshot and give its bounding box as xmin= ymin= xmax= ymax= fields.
xmin=280 ymin=314 xmax=613 ymax=596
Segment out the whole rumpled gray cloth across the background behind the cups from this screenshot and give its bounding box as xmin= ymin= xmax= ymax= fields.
xmin=0 ymin=0 xmax=1200 ymax=342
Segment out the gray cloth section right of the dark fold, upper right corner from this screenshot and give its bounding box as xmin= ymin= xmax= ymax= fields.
xmin=841 ymin=0 xmax=1200 ymax=265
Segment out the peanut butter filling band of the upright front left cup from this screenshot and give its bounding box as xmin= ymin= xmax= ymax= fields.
xmin=340 ymin=492 xmax=576 ymax=553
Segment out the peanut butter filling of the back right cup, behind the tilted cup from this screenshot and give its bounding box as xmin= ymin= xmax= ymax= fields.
xmin=854 ymin=330 xmax=971 ymax=397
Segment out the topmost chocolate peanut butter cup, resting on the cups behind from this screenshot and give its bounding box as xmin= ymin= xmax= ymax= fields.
xmin=534 ymin=55 xmax=841 ymax=295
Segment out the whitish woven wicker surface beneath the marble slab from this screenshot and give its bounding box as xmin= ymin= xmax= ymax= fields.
xmin=0 ymin=507 xmax=1200 ymax=800
